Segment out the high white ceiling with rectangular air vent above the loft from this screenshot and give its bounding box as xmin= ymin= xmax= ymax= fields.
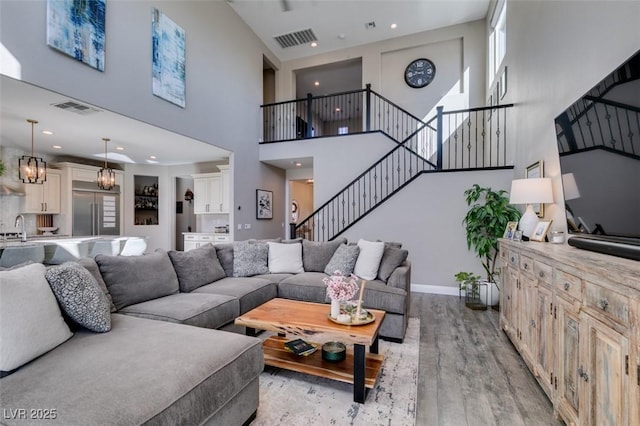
xmin=227 ymin=0 xmax=490 ymax=61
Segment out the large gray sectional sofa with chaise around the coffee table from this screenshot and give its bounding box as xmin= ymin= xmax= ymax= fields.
xmin=0 ymin=240 xmax=411 ymax=425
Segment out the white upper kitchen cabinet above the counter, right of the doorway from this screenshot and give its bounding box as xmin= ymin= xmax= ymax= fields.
xmin=192 ymin=166 xmax=230 ymax=214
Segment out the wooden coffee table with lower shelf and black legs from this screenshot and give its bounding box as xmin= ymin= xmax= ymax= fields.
xmin=235 ymin=299 xmax=385 ymax=403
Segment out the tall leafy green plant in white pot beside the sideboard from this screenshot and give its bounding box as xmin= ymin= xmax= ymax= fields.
xmin=462 ymin=184 xmax=520 ymax=306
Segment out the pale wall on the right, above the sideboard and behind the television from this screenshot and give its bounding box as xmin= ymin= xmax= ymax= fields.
xmin=504 ymin=1 xmax=640 ymax=230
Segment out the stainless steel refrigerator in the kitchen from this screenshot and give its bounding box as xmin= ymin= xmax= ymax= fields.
xmin=72 ymin=180 xmax=120 ymax=237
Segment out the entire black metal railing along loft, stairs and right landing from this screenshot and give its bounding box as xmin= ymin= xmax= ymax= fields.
xmin=263 ymin=86 xmax=513 ymax=241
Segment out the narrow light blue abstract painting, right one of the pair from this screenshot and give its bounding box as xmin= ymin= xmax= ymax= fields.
xmin=151 ymin=9 xmax=185 ymax=108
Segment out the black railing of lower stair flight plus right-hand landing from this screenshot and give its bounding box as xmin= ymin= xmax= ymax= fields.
xmin=292 ymin=104 xmax=513 ymax=241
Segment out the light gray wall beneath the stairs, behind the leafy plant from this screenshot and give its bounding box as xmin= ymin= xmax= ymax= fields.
xmin=344 ymin=170 xmax=513 ymax=294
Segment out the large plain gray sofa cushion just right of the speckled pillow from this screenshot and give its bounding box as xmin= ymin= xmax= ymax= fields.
xmin=96 ymin=251 xmax=180 ymax=310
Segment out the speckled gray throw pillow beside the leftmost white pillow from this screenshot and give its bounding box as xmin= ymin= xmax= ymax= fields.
xmin=45 ymin=262 xmax=111 ymax=333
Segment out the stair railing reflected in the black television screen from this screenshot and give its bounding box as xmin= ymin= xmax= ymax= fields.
xmin=556 ymin=96 xmax=640 ymax=159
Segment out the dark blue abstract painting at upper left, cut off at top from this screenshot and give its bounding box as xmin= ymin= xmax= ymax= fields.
xmin=47 ymin=0 xmax=106 ymax=71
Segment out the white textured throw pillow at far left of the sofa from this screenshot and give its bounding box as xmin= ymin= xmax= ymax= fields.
xmin=0 ymin=263 xmax=73 ymax=371
